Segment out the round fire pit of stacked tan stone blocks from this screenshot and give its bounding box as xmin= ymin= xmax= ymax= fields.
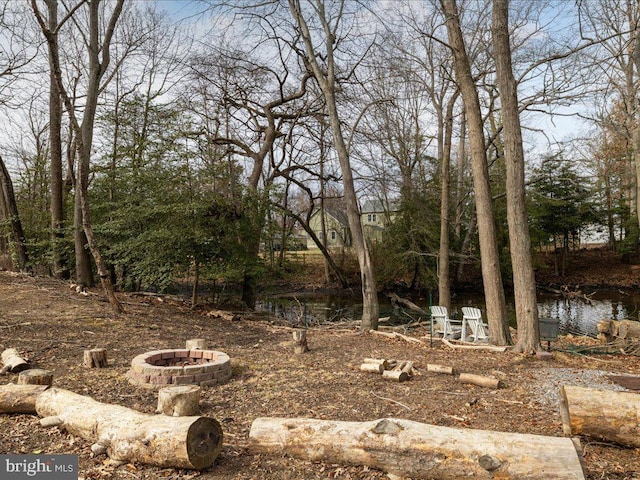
xmin=127 ymin=349 xmax=231 ymax=388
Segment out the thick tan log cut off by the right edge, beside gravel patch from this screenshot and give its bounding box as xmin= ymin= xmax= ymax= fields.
xmin=560 ymin=385 xmax=640 ymax=448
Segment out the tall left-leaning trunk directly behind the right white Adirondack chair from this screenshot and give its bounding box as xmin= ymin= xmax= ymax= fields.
xmin=441 ymin=0 xmax=511 ymax=345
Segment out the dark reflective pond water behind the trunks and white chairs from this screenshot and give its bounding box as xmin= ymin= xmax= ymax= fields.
xmin=256 ymin=290 xmax=640 ymax=337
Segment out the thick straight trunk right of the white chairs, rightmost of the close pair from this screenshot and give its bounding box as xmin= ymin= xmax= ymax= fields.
xmin=491 ymin=0 xmax=541 ymax=352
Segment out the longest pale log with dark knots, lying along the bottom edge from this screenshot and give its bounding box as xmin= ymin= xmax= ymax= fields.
xmin=249 ymin=418 xmax=584 ymax=480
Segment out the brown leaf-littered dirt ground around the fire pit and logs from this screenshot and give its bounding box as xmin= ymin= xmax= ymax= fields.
xmin=0 ymin=272 xmax=640 ymax=480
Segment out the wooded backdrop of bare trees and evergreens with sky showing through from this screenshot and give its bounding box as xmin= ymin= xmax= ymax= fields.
xmin=0 ymin=0 xmax=640 ymax=344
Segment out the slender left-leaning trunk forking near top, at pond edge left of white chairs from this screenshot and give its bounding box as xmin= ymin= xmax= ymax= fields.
xmin=289 ymin=0 xmax=379 ymax=331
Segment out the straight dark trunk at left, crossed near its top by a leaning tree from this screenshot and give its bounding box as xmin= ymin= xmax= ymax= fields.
xmin=47 ymin=0 xmax=69 ymax=278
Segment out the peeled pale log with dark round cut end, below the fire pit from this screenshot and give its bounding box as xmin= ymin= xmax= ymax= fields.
xmin=36 ymin=388 xmax=222 ymax=469
